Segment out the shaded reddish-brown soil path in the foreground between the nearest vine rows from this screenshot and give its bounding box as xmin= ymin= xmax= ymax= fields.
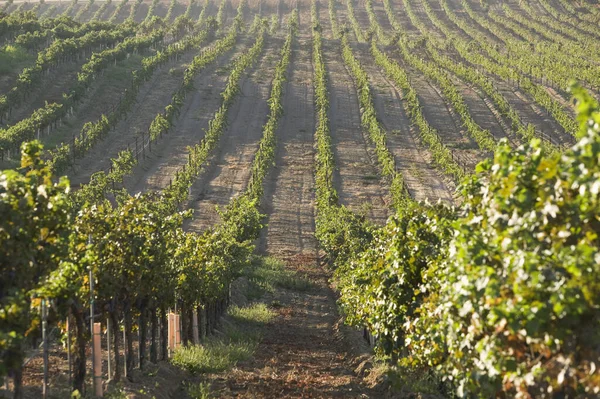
xmin=206 ymin=254 xmax=386 ymax=398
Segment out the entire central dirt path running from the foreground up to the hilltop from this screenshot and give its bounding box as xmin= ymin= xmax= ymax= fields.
xmin=197 ymin=4 xmax=382 ymax=398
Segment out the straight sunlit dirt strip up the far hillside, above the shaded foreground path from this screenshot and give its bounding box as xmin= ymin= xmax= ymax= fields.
xmin=259 ymin=7 xmax=317 ymax=262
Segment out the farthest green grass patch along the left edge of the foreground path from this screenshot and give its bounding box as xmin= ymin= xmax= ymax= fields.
xmin=245 ymin=256 xmax=314 ymax=300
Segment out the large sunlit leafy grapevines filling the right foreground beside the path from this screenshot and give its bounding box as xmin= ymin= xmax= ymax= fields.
xmin=337 ymin=87 xmax=600 ymax=398
